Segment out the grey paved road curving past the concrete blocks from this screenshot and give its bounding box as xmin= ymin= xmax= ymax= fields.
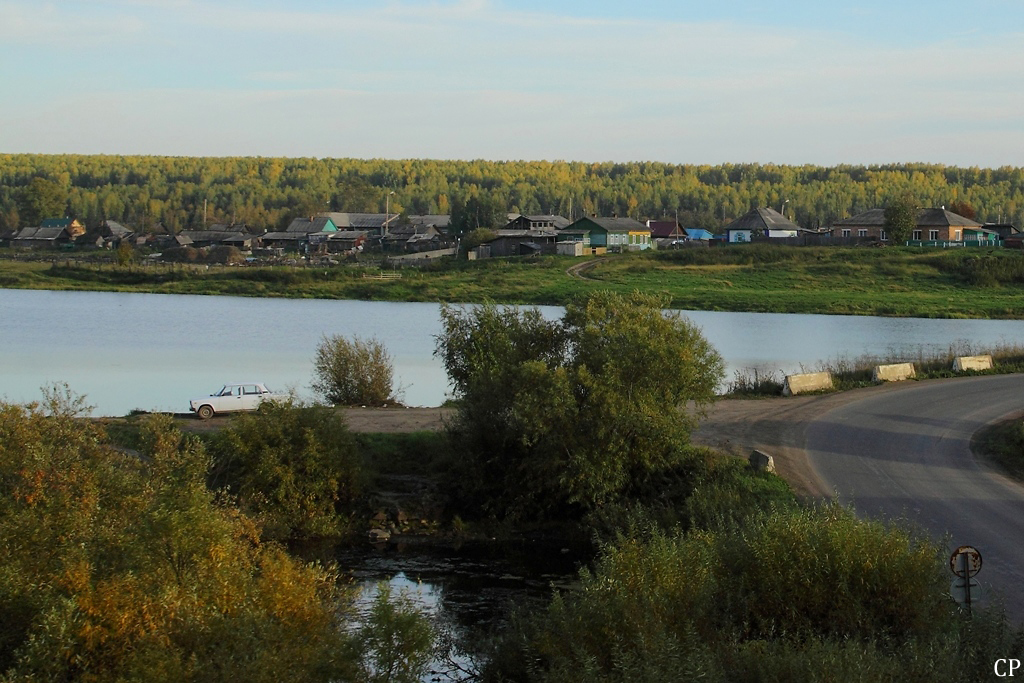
xmin=806 ymin=375 xmax=1024 ymax=623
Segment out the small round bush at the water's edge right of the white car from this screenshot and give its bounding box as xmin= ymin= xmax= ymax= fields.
xmin=312 ymin=335 xmax=397 ymax=405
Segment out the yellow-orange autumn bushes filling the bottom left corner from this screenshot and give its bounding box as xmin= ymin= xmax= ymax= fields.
xmin=0 ymin=397 xmax=361 ymax=682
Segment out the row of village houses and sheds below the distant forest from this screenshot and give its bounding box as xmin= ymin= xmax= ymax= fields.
xmin=0 ymin=207 xmax=1024 ymax=260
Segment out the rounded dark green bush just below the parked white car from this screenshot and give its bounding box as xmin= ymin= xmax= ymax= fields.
xmin=212 ymin=402 xmax=360 ymax=539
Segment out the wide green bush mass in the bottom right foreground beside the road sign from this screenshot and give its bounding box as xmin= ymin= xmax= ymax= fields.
xmin=483 ymin=506 xmax=1021 ymax=682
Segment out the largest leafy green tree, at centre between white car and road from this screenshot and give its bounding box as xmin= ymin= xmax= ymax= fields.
xmin=435 ymin=292 xmax=723 ymax=518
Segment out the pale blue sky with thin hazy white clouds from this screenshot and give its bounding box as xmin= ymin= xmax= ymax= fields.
xmin=0 ymin=0 xmax=1024 ymax=167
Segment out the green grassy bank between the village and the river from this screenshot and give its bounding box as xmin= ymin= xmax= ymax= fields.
xmin=6 ymin=245 xmax=1024 ymax=318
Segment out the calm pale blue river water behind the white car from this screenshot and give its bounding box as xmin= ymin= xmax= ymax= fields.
xmin=0 ymin=290 xmax=1024 ymax=416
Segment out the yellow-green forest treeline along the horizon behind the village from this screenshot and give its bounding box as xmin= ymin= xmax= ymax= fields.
xmin=0 ymin=154 xmax=1024 ymax=231
